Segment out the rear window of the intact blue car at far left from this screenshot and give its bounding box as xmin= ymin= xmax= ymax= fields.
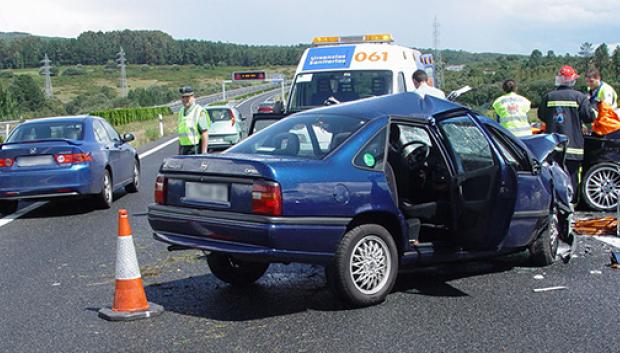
xmin=6 ymin=121 xmax=84 ymax=143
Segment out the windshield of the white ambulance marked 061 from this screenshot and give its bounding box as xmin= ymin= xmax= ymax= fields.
xmin=289 ymin=70 xmax=392 ymax=112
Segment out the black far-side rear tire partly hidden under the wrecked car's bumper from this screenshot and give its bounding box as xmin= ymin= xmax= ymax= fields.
xmin=207 ymin=253 xmax=269 ymax=286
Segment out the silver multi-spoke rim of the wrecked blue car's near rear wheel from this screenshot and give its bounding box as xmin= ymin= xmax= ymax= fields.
xmin=349 ymin=235 xmax=392 ymax=295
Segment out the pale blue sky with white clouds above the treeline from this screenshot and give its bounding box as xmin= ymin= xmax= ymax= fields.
xmin=0 ymin=0 xmax=620 ymax=55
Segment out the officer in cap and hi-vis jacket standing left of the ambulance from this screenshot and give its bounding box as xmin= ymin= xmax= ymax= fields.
xmin=178 ymin=86 xmax=211 ymax=154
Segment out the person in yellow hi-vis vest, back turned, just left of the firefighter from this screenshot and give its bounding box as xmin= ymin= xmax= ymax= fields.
xmin=493 ymin=80 xmax=532 ymax=137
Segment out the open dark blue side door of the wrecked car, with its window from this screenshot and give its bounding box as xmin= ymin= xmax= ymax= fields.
xmin=437 ymin=112 xmax=517 ymax=250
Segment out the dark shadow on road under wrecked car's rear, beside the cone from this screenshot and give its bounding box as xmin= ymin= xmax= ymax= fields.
xmin=145 ymin=265 xmax=349 ymax=321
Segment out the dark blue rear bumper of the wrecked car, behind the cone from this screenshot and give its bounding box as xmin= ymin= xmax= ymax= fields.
xmin=148 ymin=204 xmax=351 ymax=264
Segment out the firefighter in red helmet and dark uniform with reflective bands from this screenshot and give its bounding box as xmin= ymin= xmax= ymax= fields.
xmin=538 ymin=65 xmax=595 ymax=201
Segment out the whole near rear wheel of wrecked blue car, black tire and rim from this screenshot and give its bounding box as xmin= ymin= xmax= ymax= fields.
xmin=326 ymin=224 xmax=398 ymax=307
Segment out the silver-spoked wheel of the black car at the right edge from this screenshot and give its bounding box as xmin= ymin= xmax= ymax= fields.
xmin=581 ymin=163 xmax=620 ymax=211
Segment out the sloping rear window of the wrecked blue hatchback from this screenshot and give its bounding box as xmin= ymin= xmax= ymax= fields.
xmin=229 ymin=114 xmax=368 ymax=159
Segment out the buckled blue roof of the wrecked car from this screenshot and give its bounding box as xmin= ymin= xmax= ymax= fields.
xmin=295 ymin=92 xmax=464 ymax=119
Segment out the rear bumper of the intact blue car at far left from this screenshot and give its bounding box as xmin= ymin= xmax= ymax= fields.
xmin=0 ymin=164 xmax=97 ymax=199
